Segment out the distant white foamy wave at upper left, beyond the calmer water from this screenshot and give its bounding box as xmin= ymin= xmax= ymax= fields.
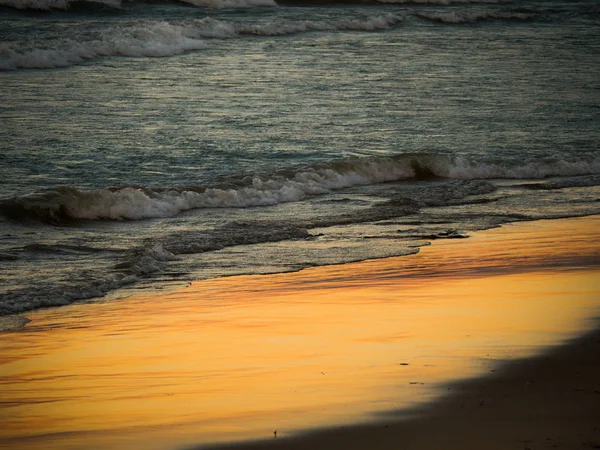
xmin=0 ymin=13 xmax=401 ymax=70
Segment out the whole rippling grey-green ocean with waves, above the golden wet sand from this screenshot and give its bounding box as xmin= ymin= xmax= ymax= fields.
xmin=0 ymin=0 xmax=600 ymax=315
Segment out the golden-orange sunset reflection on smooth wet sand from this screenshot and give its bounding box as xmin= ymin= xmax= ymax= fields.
xmin=0 ymin=217 xmax=600 ymax=449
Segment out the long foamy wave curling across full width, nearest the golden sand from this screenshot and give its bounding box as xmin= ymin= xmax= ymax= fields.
xmin=0 ymin=154 xmax=600 ymax=223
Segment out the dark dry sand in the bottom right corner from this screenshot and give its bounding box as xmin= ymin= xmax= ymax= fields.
xmin=204 ymin=329 xmax=600 ymax=450
